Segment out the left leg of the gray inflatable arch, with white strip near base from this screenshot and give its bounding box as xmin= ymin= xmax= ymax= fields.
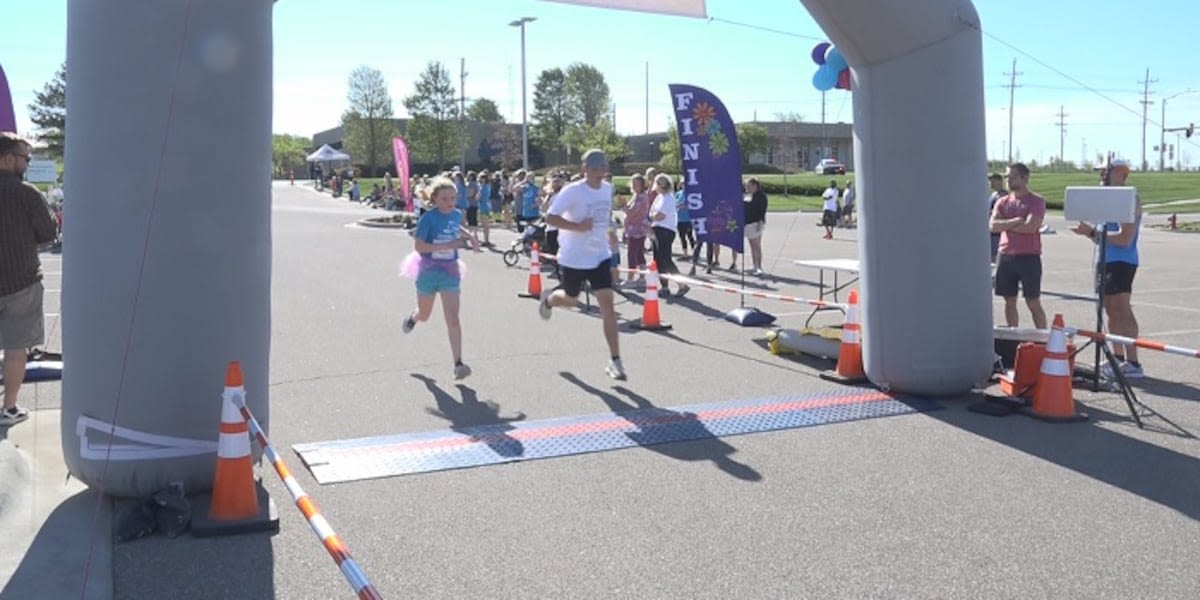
xmin=62 ymin=0 xmax=271 ymax=497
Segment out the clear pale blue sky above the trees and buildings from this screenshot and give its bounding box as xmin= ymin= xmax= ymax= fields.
xmin=7 ymin=0 xmax=1200 ymax=167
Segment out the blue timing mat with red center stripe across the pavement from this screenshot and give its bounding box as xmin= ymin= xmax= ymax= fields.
xmin=292 ymin=388 xmax=942 ymax=485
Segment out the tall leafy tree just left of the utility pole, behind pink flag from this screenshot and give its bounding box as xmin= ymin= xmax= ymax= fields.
xmin=404 ymin=61 xmax=463 ymax=167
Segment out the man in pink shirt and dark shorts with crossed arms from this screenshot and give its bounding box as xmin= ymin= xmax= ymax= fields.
xmin=991 ymin=162 xmax=1046 ymax=329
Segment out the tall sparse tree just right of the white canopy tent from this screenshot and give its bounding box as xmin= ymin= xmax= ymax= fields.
xmin=342 ymin=65 xmax=396 ymax=175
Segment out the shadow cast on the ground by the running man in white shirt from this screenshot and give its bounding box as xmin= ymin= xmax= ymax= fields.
xmin=558 ymin=372 xmax=762 ymax=481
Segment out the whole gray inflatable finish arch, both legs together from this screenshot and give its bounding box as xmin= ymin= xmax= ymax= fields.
xmin=62 ymin=0 xmax=992 ymax=497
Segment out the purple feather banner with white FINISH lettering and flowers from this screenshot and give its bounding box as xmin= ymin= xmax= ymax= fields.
xmin=670 ymin=84 xmax=745 ymax=252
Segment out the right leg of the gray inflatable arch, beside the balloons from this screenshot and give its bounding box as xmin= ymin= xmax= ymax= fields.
xmin=803 ymin=0 xmax=994 ymax=395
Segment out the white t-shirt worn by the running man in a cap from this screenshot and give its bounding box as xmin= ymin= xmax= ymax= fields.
xmin=546 ymin=179 xmax=612 ymax=269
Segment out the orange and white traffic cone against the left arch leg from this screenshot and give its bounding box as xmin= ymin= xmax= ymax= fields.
xmin=192 ymin=361 xmax=280 ymax=538
